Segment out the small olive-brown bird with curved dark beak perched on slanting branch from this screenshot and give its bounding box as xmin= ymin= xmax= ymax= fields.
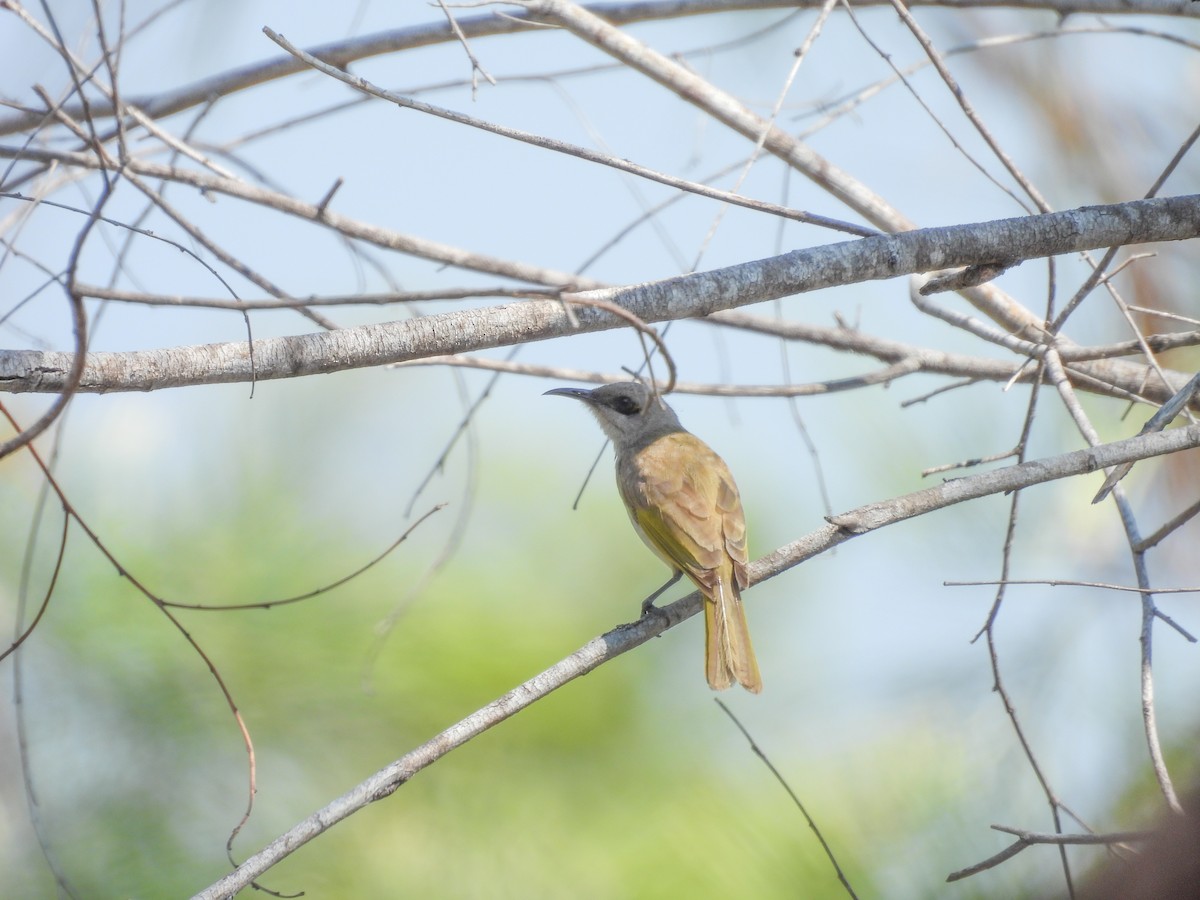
xmin=546 ymin=382 xmax=762 ymax=694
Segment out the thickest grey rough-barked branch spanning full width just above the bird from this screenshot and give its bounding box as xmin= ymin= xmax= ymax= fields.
xmin=0 ymin=195 xmax=1200 ymax=392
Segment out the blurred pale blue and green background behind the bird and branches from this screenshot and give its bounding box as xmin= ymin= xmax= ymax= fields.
xmin=0 ymin=0 xmax=1200 ymax=898
